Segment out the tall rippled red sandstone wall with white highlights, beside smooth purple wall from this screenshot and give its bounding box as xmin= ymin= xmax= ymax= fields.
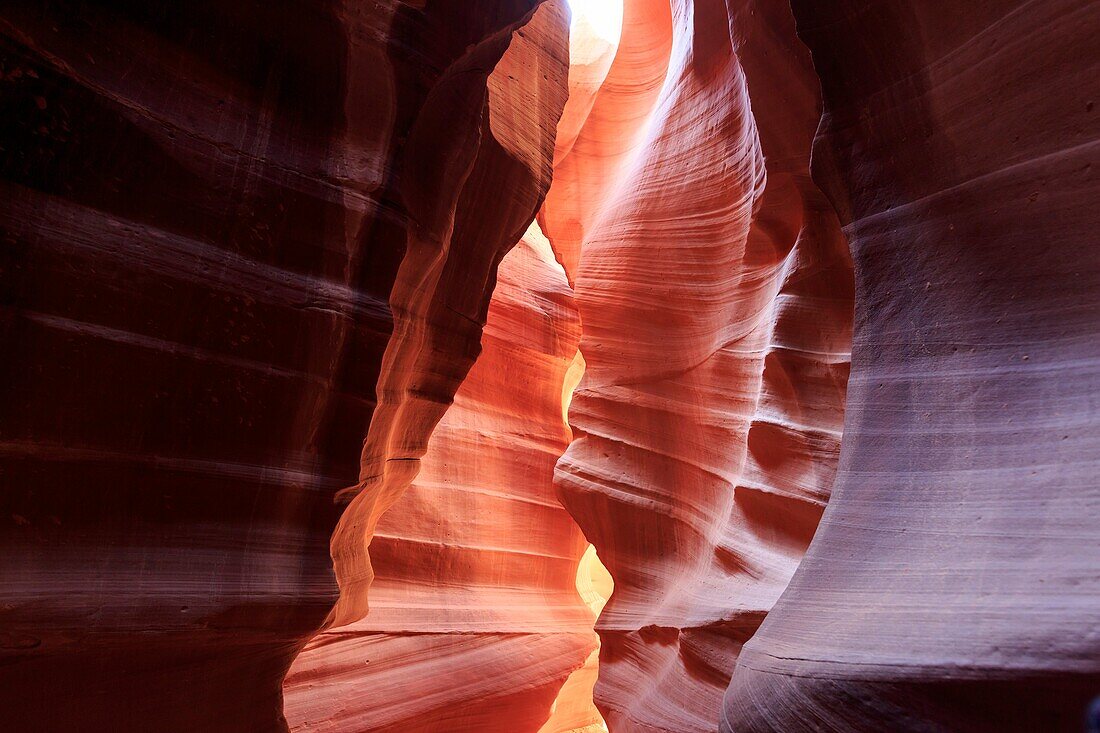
xmin=540 ymin=1 xmax=853 ymax=732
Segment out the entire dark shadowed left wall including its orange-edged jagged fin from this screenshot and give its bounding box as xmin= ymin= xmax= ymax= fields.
xmin=0 ymin=0 xmax=565 ymax=731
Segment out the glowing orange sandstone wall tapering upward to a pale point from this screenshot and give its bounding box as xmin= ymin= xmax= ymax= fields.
xmin=279 ymin=227 xmax=598 ymax=733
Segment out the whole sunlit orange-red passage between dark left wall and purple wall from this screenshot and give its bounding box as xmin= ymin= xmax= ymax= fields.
xmin=286 ymin=0 xmax=853 ymax=733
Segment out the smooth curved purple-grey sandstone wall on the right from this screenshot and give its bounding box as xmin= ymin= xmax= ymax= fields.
xmin=723 ymin=0 xmax=1100 ymax=731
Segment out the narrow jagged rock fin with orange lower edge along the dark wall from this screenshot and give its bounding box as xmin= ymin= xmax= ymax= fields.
xmin=331 ymin=0 xmax=568 ymax=625
